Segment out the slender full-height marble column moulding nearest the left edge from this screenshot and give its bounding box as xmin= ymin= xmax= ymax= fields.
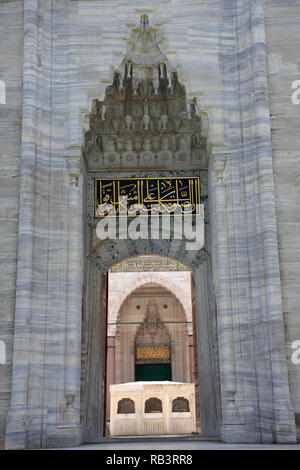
xmin=5 ymin=0 xmax=41 ymax=449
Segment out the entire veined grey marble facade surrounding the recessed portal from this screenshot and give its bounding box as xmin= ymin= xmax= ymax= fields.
xmin=0 ymin=0 xmax=300 ymax=448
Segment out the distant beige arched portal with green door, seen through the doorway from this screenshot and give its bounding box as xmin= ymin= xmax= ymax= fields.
xmin=109 ymin=283 xmax=192 ymax=383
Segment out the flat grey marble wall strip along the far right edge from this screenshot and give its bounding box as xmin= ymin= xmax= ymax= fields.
xmin=266 ymin=0 xmax=300 ymax=437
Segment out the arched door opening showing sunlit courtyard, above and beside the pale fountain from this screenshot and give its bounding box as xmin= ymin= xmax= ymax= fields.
xmin=105 ymin=255 xmax=200 ymax=435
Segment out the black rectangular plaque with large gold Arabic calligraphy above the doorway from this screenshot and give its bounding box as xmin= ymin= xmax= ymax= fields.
xmin=95 ymin=177 xmax=200 ymax=218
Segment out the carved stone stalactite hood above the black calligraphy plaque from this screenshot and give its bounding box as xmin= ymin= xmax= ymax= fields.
xmin=84 ymin=15 xmax=207 ymax=170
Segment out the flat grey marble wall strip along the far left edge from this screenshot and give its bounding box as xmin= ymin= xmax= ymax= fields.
xmin=0 ymin=0 xmax=24 ymax=449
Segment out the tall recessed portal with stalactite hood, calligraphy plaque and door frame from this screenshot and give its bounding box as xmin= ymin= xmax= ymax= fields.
xmin=81 ymin=9 xmax=219 ymax=442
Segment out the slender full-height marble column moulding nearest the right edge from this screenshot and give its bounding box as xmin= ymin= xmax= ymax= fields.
xmin=249 ymin=0 xmax=296 ymax=443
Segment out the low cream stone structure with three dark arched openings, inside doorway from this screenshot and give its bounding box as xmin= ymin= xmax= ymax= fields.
xmin=110 ymin=382 xmax=196 ymax=436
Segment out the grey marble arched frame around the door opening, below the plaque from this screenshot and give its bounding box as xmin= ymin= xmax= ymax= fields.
xmin=81 ymin=237 xmax=220 ymax=442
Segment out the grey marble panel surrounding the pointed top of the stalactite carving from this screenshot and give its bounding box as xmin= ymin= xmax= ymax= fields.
xmin=68 ymin=0 xmax=223 ymax=146
